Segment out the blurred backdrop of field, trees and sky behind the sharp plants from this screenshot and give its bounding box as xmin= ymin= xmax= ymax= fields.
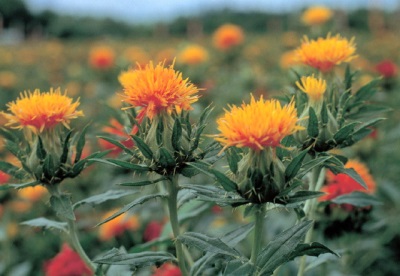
xmin=0 ymin=0 xmax=400 ymax=276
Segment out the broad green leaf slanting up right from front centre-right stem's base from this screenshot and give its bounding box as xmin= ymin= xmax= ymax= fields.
xmin=256 ymin=221 xmax=313 ymax=275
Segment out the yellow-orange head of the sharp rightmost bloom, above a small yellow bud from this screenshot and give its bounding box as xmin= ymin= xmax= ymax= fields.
xmin=296 ymin=34 xmax=357 ymax=72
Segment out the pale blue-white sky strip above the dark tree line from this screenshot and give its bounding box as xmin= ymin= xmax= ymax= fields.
xmin=24 ymin=0 xmax=400 ymax=22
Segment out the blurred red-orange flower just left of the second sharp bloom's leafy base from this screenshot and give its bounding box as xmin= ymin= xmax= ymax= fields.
xmin=99 ymin=118 xmax=134 ymax=156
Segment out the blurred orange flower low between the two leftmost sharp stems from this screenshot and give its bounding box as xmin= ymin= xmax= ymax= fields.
xmin=99 ymin=210 xmax=140 ymax=241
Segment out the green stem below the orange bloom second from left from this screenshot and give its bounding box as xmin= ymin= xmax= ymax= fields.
xmin=168 ymin=175 xmax=189 ymax=276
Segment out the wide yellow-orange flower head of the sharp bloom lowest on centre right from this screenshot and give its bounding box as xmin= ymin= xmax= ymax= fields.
xmin=215 ymin=96 xmax=301 ymax=151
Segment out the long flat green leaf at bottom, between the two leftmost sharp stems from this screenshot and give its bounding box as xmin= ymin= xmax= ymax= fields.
xmin=93 ymin=248 xmax=177 ymax=268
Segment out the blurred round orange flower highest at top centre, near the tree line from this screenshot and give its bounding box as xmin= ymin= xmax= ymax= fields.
xmin=213 ymin=24 xmax=244 ymax=50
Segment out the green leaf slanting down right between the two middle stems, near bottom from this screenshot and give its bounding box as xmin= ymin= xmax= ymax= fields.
xmin=177 ymin=232 xmax=241 ymax=258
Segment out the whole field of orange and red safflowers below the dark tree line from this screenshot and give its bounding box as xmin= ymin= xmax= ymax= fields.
xmin=0 ymin=5 xmax=400 ymax=276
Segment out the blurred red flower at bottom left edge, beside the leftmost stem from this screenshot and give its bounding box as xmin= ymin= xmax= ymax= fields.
xmin=43 ymin=244 xmax=93 ymax=276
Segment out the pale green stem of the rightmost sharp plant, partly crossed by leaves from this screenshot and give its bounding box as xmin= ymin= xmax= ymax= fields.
xmin=297 ymin=166 xmax=325 ymax=276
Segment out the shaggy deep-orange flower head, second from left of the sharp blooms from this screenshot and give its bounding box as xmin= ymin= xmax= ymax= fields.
xmin=119 ymin=62 xmax=199 ymax=121
